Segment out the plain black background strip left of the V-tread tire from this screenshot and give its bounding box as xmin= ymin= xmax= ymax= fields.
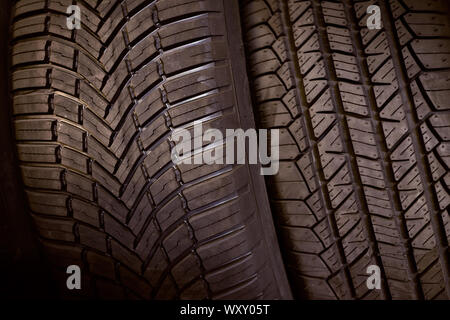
xmin=0 ymin=0 xmax=52 ymax=298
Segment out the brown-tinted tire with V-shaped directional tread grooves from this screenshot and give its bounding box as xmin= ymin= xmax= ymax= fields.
xmin=11 ymin=0 xmax=290 ymax=299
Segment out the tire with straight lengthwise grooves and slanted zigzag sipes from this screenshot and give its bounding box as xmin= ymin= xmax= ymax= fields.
xmin=241 ymin=0 xmax=450 ymax=299
